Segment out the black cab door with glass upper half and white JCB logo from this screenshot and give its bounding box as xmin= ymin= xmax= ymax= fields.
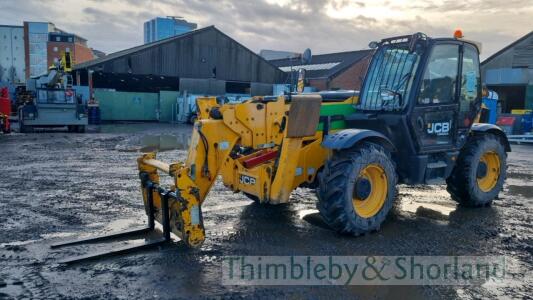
xmin=411 ymin=43 xmax=460 ymax=153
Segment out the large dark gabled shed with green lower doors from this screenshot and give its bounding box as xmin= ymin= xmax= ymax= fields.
xmin=73 ymin=26 xmax=286 ymax=121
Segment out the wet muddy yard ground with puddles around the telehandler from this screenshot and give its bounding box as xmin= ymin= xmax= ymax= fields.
xmin=0 ymin=124 xmax=533 ymax=299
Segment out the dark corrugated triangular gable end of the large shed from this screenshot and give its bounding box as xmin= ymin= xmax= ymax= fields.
xmin=74 ymin=26 xmax=285 ymax=83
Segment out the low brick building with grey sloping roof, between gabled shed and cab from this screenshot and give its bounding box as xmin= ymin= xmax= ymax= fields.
xmin=270 ymin=50 xmax=372 ymax=91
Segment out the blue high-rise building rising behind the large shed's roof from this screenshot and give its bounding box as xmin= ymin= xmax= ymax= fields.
xmin=144 ymin=17 xmax=198 ymax=44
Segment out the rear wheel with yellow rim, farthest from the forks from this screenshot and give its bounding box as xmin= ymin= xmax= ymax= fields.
xmin=446 ymin=134 xmax=507 ymax=207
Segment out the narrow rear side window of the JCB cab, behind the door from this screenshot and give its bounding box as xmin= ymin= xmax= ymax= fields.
xmin=459 ymin=45 xmax=481 ymax=124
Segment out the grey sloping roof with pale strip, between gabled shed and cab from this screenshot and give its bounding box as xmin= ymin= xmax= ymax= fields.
xmin=270 ymin=50 xmax=372 ymax=79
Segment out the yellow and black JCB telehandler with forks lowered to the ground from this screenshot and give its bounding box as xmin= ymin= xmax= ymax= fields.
xmin=54 ymin=33 xmax=511 ymax=263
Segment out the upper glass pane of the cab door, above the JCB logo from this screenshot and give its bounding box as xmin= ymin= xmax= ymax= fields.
xmin=418 ymin=45 xmax=459 ymax=104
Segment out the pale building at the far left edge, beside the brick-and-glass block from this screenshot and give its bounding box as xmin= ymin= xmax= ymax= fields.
xmin=0 ymin=25 xmax=26 ymax=84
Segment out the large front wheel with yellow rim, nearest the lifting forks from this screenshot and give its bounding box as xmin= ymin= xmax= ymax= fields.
xmin=317 ymin=143 xmax=397 ymax=235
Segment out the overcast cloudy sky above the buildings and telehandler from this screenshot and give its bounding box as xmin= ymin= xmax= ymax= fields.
xmin=0 ymin=0 xmax=533 ymax=58
